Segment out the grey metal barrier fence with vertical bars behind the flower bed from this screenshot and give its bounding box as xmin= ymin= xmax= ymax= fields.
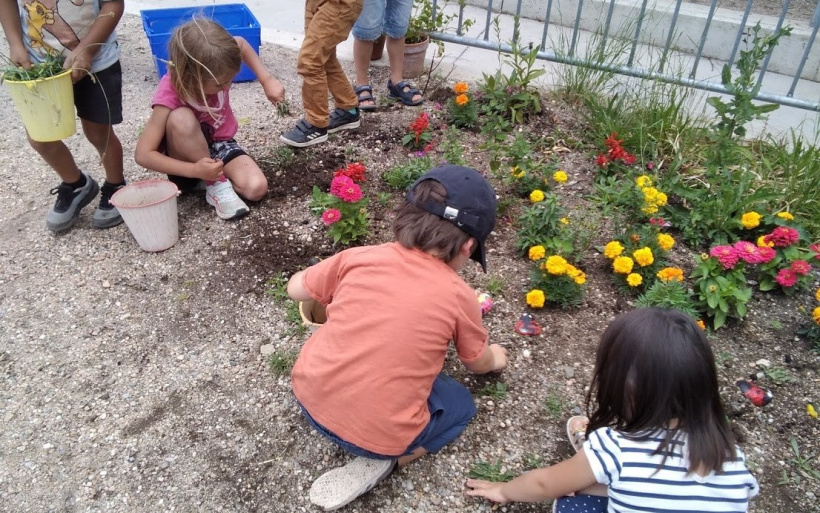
xmin=431 ymin=0 xmax=820 ymax=111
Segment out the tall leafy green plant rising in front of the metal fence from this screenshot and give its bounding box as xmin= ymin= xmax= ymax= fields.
xmin=706 ymin=22 xmax=792 ymax=165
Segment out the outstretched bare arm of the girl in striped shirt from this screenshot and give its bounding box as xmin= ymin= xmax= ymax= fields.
xmin=467 ymin=451 xmax=597 ymax=502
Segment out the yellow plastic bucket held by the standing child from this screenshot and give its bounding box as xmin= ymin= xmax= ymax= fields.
xmin=5 ymin=70 xmax=77 ymax=142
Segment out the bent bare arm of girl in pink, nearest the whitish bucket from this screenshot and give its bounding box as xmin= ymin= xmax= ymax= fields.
xmin=134 ymin=105 xmax=222 ymax=181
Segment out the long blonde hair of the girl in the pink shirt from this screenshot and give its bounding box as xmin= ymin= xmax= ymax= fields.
xmin=168 ymin=17 xmax=242 ymax=110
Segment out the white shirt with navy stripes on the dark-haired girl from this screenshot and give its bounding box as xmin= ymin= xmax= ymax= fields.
xmin=584 ymin=428 xmax=759 ymax=513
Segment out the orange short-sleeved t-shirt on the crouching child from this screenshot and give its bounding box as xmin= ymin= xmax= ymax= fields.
xmin=291 ymin=242 xmax=487 ymax=456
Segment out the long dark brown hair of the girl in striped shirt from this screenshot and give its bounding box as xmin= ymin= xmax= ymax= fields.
xmin=586 ymin=308 xmax=736 ymax=473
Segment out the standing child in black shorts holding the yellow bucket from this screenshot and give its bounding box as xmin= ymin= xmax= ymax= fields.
xmin=0 ymin=0 xmax=125 ymax=232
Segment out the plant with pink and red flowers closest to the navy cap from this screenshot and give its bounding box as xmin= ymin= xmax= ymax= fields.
xmin=310 ymin=162 xmax=369 ymax=244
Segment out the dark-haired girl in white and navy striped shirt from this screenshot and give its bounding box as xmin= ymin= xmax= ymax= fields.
xmin=467 ymin=308 xmax=758 ymax=513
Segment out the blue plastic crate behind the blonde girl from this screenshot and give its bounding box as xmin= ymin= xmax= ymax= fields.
xmin=140 ymin=4 xmax=261 ymax=82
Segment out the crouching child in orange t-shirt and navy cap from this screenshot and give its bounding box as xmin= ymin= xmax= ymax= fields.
xmin=288 ymin=165 xmax=507 ymax=511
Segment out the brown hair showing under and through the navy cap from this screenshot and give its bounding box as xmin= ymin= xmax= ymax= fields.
xmin=393 ymin=180 xmax=470 ymax=263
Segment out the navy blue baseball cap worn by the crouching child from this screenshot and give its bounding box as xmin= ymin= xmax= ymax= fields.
xmin=407 ymin=164 xmax=496 ymax=272
